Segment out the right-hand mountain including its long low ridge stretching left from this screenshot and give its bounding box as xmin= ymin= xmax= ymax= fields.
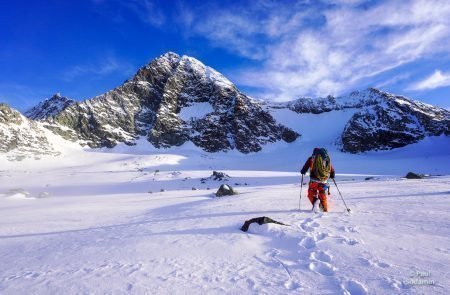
xmin=286 ymin=88 xmax=450 ymax=153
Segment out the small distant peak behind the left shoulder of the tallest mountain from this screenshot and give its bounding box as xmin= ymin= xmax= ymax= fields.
xmin=24 ymin=93 xmax=76 ymax=120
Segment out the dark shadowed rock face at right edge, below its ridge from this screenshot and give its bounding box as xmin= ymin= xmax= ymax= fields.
xmin=341 ymin=90 xmax=450 ymax=153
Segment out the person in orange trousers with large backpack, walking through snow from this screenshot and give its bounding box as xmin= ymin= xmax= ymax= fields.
xmin=301 ymin=148 xmax=335 ymax=212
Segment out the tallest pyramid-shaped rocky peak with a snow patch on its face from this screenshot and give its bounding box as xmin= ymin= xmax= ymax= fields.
xmin=39 ymin=53 xmax=299 ymax=153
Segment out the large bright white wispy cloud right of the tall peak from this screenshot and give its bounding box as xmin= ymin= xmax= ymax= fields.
xmin=178 ymin=0 xmax=450 ymax=100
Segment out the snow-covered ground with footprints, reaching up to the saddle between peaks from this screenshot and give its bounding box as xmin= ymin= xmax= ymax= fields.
xmin=0 ymin=109 xmax=450 ymax=294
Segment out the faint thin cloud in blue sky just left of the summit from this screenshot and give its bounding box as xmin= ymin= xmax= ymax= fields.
xmin=62 ymin=56 xmax=134 ymax=82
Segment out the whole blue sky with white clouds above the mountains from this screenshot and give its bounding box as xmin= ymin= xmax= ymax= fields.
xmin=0 ymin=0 xmax=450 ymax=111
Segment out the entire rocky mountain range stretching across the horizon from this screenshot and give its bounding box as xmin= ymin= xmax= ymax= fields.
xmin=0 ymin=52 xmax=450 ymax=160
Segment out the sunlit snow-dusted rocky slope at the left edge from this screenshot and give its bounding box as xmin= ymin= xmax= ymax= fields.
xmin=0 ymin=104 xmax=57 ymax=160
